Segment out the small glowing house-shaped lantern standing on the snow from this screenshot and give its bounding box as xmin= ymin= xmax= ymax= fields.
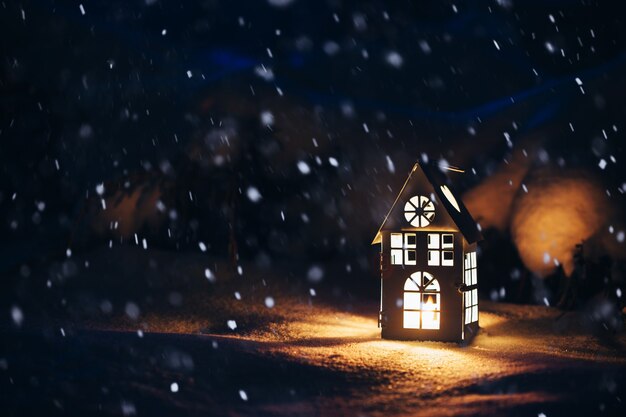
xmin=372 ymin=163 xmax=482 ymax=342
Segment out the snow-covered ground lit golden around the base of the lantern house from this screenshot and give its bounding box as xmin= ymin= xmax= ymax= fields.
xmin=0 ymin=296 xmax=626 ymax=416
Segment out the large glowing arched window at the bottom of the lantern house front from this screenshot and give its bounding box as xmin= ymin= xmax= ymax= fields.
xmin=404 ymin=272 xmax=441 ymax=329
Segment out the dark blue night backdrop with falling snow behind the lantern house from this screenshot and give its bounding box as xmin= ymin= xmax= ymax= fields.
xmin=0 ymin=0 xmax=626 ymax=302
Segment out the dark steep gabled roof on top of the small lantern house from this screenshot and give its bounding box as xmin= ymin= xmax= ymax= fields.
xmin=372 ymin=163 xmax=482 ymax=245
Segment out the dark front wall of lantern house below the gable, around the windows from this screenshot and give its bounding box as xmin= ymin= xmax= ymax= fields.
xmin=381 ymin=230 xmax=465 ymax=342
